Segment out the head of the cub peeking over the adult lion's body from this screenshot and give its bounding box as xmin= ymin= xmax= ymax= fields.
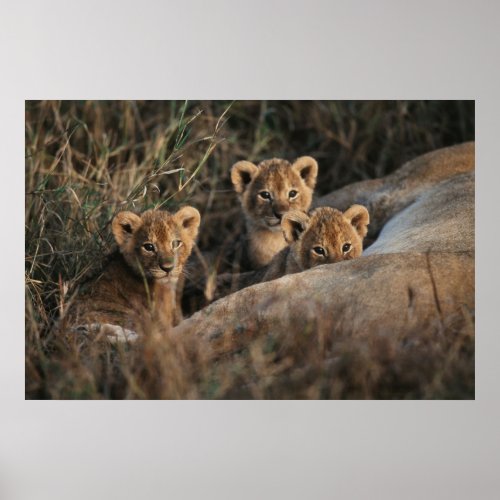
xmin=281 ymin=205 xmax=370 ymax=269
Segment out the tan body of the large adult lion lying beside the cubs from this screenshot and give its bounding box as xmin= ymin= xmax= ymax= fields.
xmin=175 ymin=143 xmax=474 ymax=397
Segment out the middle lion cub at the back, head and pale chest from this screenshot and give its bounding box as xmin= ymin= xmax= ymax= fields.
xmin=231 ymin=156 xmax=318 ymax=269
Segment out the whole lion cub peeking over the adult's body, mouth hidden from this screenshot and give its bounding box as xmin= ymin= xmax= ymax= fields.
xmin=217 ymin=205 xmax=370 ymax=298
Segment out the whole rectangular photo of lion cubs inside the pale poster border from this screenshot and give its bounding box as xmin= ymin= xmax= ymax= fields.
xmin=25 ymin=100 xmax=475 ymax=400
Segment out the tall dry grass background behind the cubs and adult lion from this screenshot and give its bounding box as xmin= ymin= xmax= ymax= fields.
xmin=25 ymin=101 xmax=475 ymax=397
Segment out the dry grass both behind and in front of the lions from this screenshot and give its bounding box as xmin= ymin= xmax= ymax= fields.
xmin=25 ymin=101 xmax=474 ymax=398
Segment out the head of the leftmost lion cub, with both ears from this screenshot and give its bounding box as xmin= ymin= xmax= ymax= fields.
xmin=112 ymin=207 xmax=200 ymax=280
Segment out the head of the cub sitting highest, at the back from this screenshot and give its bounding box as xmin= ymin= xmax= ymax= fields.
xmin=231 ymin=156 xmax=318 ymax=232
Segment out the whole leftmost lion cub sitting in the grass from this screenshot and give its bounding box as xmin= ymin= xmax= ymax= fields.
xmin=66 ymin=207 xmax=200 ymax=340
